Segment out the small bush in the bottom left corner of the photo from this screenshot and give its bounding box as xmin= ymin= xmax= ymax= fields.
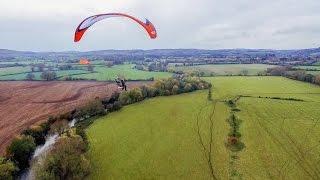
xmin=0 ymin=157 xmax=18 ymax=180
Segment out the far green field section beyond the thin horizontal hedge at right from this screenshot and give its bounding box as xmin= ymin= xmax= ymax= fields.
xmin=205 ymin=76 xmax=320 ymax=101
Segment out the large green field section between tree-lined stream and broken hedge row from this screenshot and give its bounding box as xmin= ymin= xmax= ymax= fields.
xmin=88 ymin=92 xmax=228 ymax=179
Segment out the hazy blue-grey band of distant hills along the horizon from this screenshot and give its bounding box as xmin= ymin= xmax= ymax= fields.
xmin=0 ymin=48 xmax=320 ymax=60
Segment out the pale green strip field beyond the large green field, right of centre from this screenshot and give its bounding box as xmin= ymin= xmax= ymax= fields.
xmin=171 ymin=64 xmax=275 ymax=75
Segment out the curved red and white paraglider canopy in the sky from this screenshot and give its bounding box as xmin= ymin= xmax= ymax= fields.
xmin=74 ymin=13 xmax=157 ymax=42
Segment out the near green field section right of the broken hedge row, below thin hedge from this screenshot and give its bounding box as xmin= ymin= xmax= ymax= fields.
xmin=238 ymin=98 xmax=320 ymax=179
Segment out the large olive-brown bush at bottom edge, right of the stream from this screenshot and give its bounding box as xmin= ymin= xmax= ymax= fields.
xmin=35 ymin=135 xmax=90 ymax=179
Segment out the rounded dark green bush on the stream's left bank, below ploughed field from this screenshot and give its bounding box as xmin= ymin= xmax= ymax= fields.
xmin=7 ymin=135 xmax=36 ymax=170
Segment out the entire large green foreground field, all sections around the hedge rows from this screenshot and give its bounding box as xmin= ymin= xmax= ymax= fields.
xmin=88 ymin=77 xmax=320 ymax=179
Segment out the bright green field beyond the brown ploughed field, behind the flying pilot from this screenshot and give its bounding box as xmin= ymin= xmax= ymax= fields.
xmin=72 ymin=64 xmax=171 ymax=81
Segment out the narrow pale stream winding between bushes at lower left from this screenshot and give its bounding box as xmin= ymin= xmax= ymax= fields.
xmin=18 ymin=119 xmax=76 ymax=180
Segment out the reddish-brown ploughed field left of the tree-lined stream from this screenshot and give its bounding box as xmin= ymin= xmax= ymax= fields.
xmin=0 ymin=81 xmax=145 ymax=155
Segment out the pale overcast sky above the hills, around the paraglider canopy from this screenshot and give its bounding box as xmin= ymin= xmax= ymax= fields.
xmin=0 ymin=0 xmax=320 ymax=51
